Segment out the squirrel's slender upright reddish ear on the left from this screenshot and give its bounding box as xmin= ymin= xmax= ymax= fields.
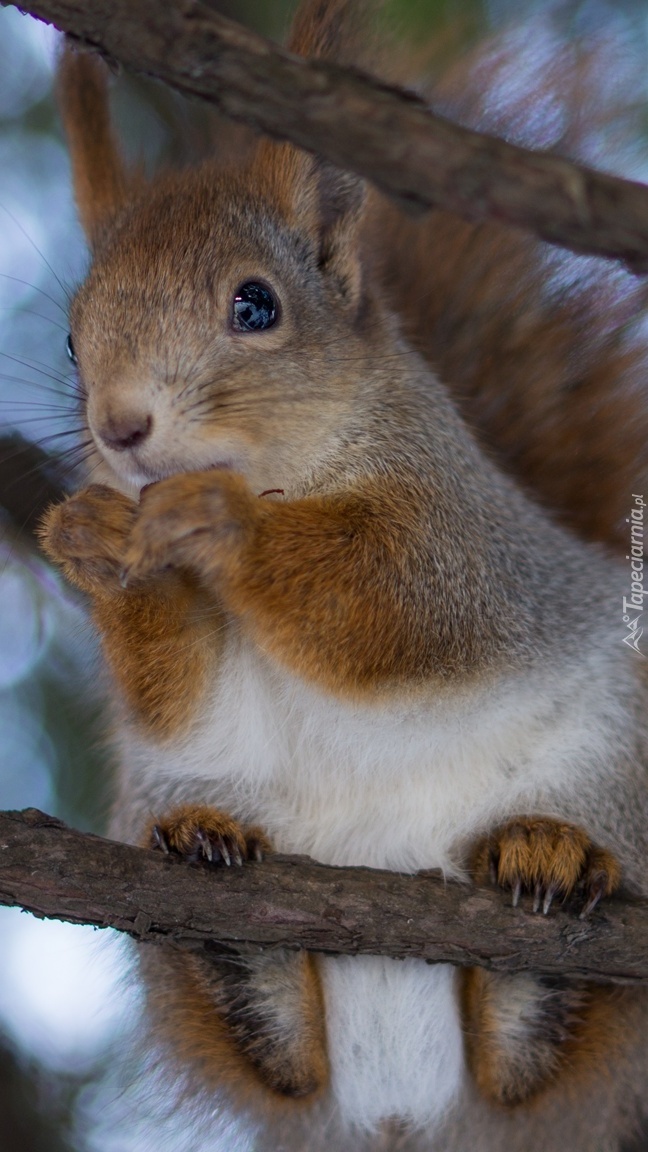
xmin=58 ymin=45 xmax=129 ymax=247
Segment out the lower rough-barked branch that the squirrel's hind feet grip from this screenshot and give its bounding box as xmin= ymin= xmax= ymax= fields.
xmin=0 ymin=809 xmax=648 ymax=983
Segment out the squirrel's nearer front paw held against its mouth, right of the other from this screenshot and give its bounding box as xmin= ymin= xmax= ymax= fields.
xmin=123 ymin=470 xmax=254 ymax=582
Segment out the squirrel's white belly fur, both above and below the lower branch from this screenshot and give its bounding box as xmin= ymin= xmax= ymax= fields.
xmin=122 ymin=641 xmax=618 ymax=1127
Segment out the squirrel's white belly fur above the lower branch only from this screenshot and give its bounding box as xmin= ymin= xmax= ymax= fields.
xmin=125 ymin=643 xmax=585 ymax=872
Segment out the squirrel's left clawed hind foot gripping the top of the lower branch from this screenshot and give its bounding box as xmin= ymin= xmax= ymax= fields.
xmin=149 ymin=804 xmax=272 ymax=865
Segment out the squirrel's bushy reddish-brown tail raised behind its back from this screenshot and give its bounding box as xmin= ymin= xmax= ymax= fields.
xmin=371 ymin=203 xmax=648 ymax=547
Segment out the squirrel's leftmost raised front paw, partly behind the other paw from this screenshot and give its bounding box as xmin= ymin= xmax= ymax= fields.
xmin=38 ymin=484 xmax=137 ymax=592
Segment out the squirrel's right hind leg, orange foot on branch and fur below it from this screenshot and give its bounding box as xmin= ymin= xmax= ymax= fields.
xmin=461 ymin=817 xmax=621 ymax=1106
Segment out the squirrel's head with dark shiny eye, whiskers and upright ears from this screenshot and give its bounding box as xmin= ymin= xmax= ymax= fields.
xmin=60 ymin=25 xmax=389 ymax=491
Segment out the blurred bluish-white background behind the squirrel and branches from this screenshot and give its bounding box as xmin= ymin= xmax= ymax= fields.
xmin=0 ymin=0 xmax=648 ymax=1152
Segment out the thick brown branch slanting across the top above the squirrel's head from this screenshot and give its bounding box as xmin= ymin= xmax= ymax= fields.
xmin=0 ymin=0 xmax=648 ymax=272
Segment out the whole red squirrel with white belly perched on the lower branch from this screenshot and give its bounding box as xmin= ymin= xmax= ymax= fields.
xmin=42 ymin=0 xmax=648 ymax=1152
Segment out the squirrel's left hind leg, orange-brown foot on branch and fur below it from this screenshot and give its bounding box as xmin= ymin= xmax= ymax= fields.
xmin=138 ymin=804 xmax=329 ymax=1109
